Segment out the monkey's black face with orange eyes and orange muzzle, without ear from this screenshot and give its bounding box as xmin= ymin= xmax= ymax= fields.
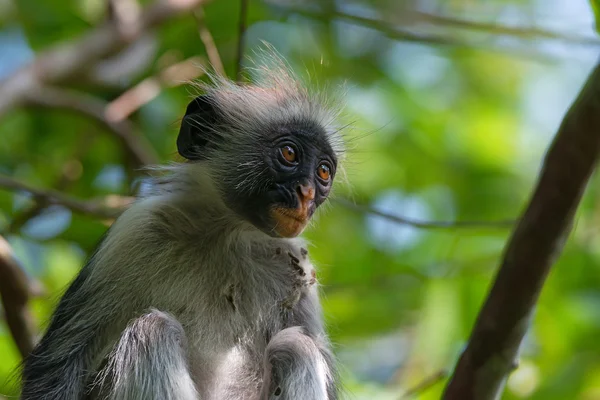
xmin=228 ymin=122 xmax=337 ymax=237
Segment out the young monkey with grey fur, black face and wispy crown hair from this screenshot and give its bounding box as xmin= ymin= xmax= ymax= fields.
xmin=21 ymin=60 xmax=343 ymax=400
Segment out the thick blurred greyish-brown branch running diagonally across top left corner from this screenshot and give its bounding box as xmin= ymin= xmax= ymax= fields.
xmin=0 ymin=0 xmax=204 ymax=117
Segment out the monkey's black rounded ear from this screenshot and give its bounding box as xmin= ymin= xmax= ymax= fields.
xmin=177 ymin=96 xmax=218 ymax=160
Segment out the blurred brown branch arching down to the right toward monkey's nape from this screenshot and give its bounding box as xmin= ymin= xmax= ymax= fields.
xmin=23 ymin=86 xmax=159 ymax=166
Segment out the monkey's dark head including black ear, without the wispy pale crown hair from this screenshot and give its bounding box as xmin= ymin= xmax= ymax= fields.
xmin=177 ymin=96 xmax=337 ymax=238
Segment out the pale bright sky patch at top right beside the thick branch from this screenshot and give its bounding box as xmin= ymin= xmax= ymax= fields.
xmin=516 ymin=0 xmax=598 ymax=171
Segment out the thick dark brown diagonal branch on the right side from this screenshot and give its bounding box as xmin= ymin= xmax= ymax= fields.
xmin=443 ymin=60 xmax=600 ymax=400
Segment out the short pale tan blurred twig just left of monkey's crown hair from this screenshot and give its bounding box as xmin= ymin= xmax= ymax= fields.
xmin=105 ymin=57 xmax=204 ymax=123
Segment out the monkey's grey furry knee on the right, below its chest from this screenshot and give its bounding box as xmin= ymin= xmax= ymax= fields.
xmin=260 ymin=326 xmax=331 ymax=400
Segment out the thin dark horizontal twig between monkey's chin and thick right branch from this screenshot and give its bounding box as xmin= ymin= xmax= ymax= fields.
xmin=335 ymin=198 xmax=516 ymax=229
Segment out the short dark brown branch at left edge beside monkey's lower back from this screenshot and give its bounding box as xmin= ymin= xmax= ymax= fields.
xmin=0 ymin=236 xmax=35 ymax=357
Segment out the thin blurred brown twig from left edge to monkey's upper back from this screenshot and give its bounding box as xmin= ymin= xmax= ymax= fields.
xmin=0 ymin=175 xmax=133 ymax=219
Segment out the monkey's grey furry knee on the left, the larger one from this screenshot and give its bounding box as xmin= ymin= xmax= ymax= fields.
xmin=94 ymin=310 xmax=198 ymax=400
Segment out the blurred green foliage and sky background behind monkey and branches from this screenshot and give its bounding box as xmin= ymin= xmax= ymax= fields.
xmin=0 ymin=0 xmax=600 ymax=400
